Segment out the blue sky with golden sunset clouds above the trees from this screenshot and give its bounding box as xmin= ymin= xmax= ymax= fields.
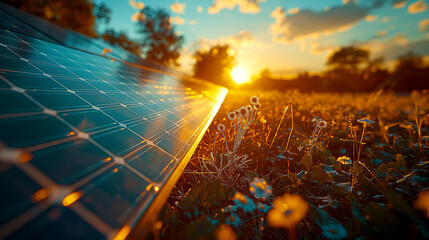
xmin=95 ymin=0 xmax=429 ymax=76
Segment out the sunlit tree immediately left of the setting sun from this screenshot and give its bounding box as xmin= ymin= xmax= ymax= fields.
xmin=194 ymin=45 xmax=235 ymax=87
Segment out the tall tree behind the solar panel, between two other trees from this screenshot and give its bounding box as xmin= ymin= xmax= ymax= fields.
xmin=138 ymin=7 xmax=183 ymax=66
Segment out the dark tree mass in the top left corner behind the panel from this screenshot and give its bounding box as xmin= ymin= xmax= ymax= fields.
xmin=4 ymin=0 xmax=110 ymax=37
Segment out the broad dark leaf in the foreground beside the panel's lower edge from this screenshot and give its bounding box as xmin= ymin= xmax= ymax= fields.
xmin=179 ymin=178 xmax=227 ymax=211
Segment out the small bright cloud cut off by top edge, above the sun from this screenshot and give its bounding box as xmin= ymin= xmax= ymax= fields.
xmin=208 ymin=0 xmax=266 ymax=14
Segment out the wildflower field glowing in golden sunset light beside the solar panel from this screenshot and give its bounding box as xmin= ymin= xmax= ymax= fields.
xmin=154 ymin=90 xmax=429 ymax=239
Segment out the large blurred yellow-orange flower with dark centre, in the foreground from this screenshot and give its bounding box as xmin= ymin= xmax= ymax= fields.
xmin=267 ymin=193 xmax=309 ymax=228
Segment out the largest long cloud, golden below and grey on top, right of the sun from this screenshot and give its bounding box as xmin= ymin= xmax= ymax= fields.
xmin=270 ymin=4 xmax=370 ymax=43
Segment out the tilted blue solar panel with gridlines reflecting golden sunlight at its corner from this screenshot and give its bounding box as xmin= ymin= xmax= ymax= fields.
xmin=0 ymin=4 xmax=226 ymax=239
